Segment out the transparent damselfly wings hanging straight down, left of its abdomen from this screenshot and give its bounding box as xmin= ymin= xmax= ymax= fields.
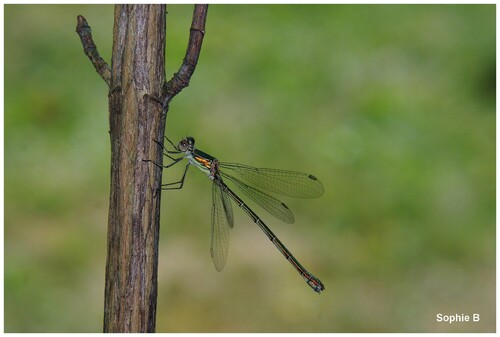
xmin=210 ymin=181 xmax=233 ymax=271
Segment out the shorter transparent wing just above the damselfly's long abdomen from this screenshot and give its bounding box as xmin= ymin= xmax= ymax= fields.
xmin=221 ymin=173 xmax=295 ymax=223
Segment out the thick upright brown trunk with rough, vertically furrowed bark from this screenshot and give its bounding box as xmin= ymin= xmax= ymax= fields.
xmin=104 ymin=5 xmax=166 ymax=332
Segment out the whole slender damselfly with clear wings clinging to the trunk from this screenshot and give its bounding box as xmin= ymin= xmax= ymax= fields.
xmin=146 ymin=137 xmax=325 ymax=293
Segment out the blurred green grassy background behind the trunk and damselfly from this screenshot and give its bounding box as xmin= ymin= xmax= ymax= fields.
xmin=4 ymin=5 xmax=496 ymax=332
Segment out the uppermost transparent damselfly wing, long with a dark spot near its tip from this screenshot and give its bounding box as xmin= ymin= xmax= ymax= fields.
xmin=219 ymin=163 xmax=324 ymax=198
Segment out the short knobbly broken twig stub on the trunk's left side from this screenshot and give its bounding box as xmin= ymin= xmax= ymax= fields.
xmin=76 ymin=15 xmax=111 ymax=87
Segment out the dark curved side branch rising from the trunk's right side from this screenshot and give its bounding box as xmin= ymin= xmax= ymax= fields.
xmin=162 ymin=5 xmax=208 ymax=106
